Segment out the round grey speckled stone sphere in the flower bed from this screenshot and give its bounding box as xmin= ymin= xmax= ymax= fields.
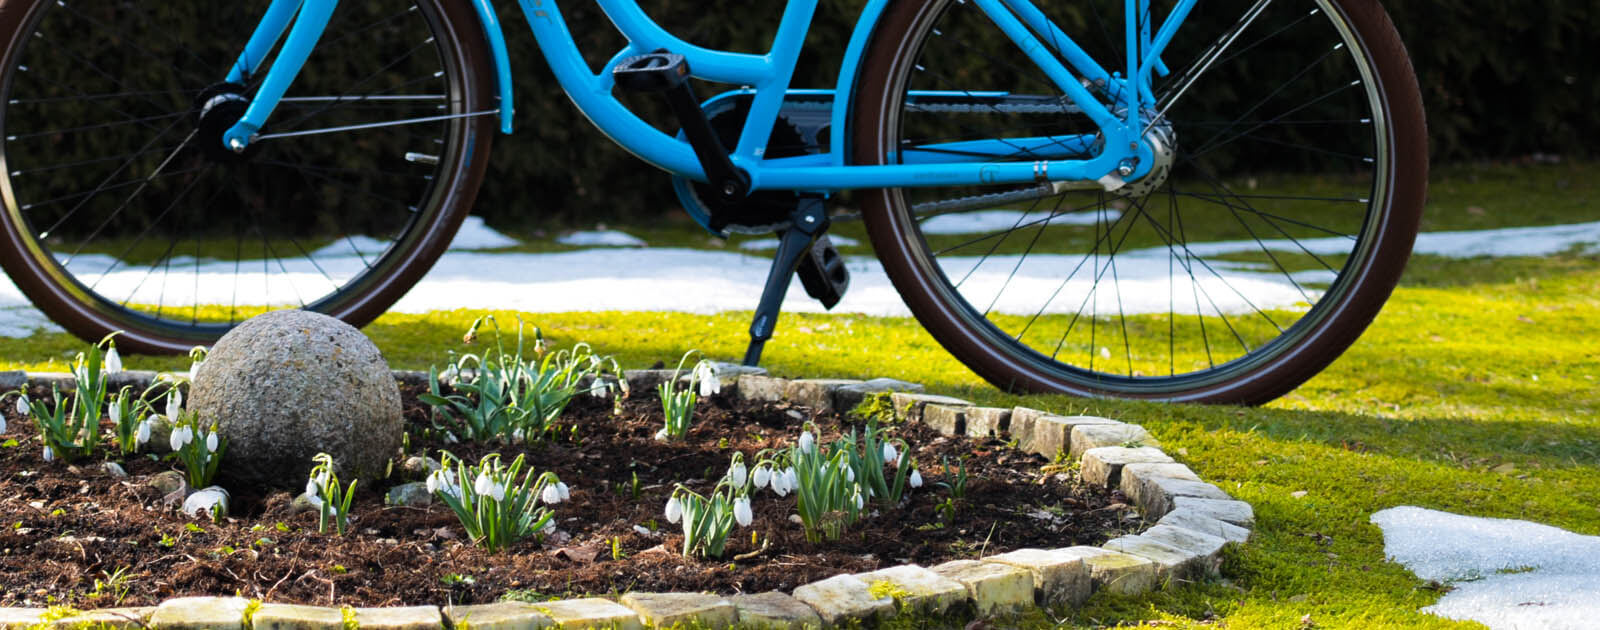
xmin=187 ymin=310 xmax=403 ymax=489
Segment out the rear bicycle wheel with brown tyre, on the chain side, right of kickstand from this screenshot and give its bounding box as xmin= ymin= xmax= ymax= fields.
xmin=851 ymin=0 xmax=1427 ymax=403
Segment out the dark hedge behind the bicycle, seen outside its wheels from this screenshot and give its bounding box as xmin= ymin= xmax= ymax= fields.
xmin=478 ymin=0 xmax=1600 ymax=225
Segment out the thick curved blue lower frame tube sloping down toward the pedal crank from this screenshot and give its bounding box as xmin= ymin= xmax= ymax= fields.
xmin=518 ymin=0 xmax=706 ymax=181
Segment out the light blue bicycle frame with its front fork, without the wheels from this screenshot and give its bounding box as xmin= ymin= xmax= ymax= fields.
xmin=222 ymin=0 xmax=1198 ymax=192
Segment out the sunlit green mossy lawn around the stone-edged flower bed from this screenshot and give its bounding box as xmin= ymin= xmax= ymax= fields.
xmin=0 ymin=161 xmax=1600 ymax=628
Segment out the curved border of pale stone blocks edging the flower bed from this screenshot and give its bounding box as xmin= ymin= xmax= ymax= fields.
xmin=0 ymin=363 xmax=1254 ymax=630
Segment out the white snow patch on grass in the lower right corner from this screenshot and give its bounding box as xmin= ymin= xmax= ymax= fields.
xmin=1371 ymin=507 xmax=1600 ymax=630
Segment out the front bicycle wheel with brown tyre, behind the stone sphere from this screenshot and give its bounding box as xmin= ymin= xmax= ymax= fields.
xmin=0 ymin=0 xmax=496 ymax=352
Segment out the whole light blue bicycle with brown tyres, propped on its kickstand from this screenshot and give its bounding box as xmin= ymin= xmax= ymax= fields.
xmin=0 ymin=0 xmax=1427 ymax=403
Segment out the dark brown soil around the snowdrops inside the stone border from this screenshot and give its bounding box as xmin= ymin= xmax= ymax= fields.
xmin=0 ymin=387 xmax=1136 ymax=608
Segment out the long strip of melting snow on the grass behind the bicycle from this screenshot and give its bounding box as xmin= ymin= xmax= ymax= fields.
xmin=0 ymin=217 xmax=1600 ymax=336
